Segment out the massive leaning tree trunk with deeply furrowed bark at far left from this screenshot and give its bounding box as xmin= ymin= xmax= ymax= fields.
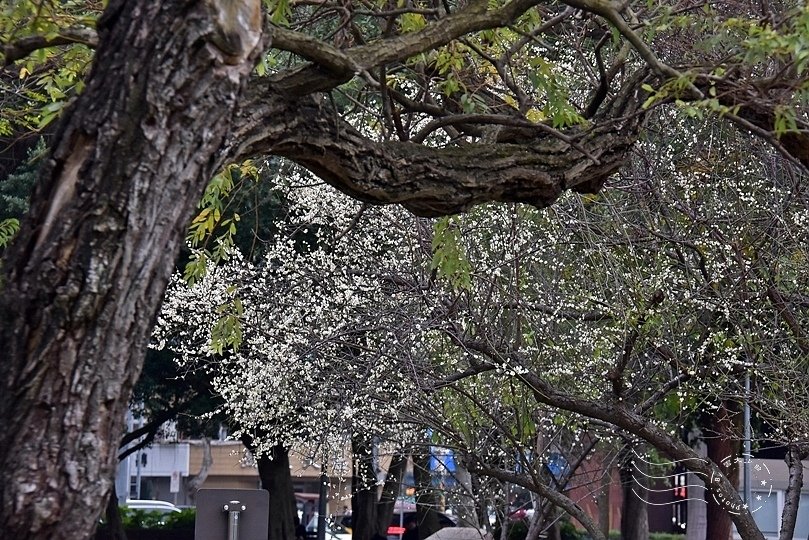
xmin=0 ymin=0 xmax=261 ymax=540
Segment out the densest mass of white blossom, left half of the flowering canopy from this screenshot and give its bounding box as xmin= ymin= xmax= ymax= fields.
xmin=153 ymin=169 xmax=442 ymax=456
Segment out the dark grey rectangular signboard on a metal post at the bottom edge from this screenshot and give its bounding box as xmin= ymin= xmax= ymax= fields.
xmin=194 ymin=489 xmax=270 ymax=540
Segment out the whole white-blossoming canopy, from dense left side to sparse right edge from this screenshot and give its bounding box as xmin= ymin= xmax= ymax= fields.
xmin=155 ymin=109 xmax=809 ymax=472
